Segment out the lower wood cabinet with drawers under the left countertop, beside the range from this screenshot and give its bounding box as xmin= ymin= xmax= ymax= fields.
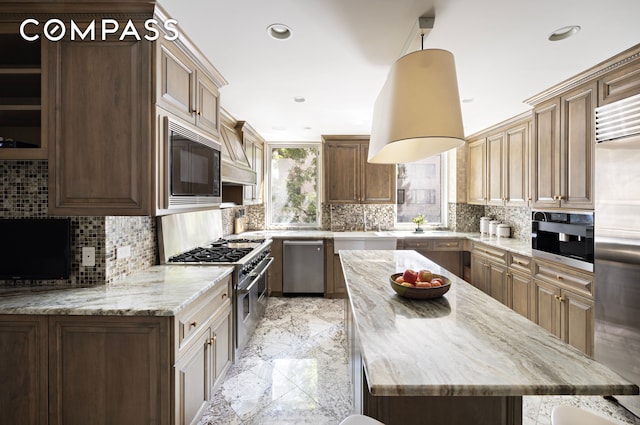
xmin=0 ymin=277 xmax=233 ymax=425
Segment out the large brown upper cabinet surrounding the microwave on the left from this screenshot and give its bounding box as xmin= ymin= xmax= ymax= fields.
xmin=46 ymin=6 xmax=225 ymax=216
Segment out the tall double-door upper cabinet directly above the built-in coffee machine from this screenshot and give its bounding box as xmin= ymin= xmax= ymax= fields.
xmin=532 ymin=82 xmax=597 ymax=209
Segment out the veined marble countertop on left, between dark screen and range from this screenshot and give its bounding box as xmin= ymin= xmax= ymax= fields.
xmin=0 ymin=265 xmax=233 ymax=316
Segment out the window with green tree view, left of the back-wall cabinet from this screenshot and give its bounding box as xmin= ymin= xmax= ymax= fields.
xmin=267 ymin=144 xmax=320 ymax=228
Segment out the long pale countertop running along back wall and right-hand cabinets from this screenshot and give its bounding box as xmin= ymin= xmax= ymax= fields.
xmin=238 ymin=230 xmax=531 ymax=257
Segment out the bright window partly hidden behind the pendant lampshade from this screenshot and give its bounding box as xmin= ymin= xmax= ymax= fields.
xmin=396 ymin=154 xmax=447 ymax=226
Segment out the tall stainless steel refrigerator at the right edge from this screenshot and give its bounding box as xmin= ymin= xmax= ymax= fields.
xmin=594 ymin=97 xmax=640 ymax=416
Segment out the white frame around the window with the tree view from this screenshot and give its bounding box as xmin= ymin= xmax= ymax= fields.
xmin=265 ymin=142 xmax=324 ymax=230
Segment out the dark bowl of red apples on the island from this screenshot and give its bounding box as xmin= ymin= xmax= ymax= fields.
xmin=389 ymin=269 xmax=451 ymax=300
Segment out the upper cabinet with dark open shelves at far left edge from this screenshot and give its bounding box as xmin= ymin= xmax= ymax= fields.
xmin=0 ymin=23 xmax=49 ymax=160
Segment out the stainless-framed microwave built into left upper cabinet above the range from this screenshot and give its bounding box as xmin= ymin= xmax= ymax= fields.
xmin=163 ymin=117 xmax=222 ymax=209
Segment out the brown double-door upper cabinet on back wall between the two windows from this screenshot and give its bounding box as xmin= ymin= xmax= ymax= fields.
xmin=322 ymin=136 xmax=396 ymax=204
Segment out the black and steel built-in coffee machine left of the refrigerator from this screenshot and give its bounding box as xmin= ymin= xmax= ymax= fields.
xmin=531 ymin=211 xmax=594 ymax=272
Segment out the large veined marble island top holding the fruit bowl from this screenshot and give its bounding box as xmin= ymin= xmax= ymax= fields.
xmin=340 ymin=251 xmax=638 ymax=396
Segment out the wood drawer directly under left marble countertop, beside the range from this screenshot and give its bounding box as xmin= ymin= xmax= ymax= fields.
xmin=176 ymin=276 xmax=231 ymax=351
